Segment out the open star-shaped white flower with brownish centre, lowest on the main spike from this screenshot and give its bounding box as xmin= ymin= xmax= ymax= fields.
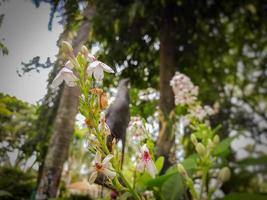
xmin=89 ymin=151 xmax=116 ymax=184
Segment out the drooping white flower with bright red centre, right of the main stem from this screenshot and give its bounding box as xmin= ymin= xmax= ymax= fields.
xmin=136 ymin=144 xmax=157 ymax=177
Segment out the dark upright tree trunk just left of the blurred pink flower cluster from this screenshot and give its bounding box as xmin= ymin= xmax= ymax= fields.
xmin=157 ymin=3 xmax=176 ymax=172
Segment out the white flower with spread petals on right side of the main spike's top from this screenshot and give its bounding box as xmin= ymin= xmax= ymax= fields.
xmin=87 ymin=60 xmax=114 ymax=81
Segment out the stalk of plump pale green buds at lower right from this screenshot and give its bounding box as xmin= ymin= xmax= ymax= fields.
xmin=180 ymin=128 xmax=231 ymax=200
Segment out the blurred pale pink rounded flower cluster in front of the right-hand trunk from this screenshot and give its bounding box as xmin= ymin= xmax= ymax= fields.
xmin=170 ymin=72 xmax=198 ymax=105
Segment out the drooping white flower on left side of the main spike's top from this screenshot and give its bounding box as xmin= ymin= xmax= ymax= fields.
xmin=52 ymin=67 xmax=77 ymax=88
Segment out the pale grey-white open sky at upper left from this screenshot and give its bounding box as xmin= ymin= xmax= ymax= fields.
xmin=0 ymin=0 xmax=63 ymax=103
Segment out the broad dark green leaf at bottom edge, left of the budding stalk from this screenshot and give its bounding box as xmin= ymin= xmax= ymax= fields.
xmin=161 ymin=173 xmax=185 ymax=200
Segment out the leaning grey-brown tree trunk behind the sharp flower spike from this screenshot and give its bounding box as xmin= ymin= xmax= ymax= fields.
xmin=36 ymin=5 xmax=93 ymax=200
